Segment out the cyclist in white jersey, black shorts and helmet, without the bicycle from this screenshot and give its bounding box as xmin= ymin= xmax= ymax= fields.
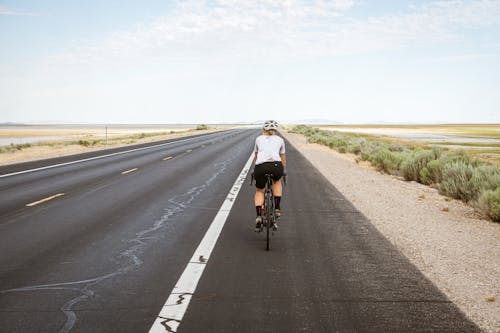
xmin=252 ymin=120 xmax=286 ymax=232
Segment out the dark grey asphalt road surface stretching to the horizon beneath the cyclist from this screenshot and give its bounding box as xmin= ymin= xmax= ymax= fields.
xmin=0 ymin=130 xmax=479 ymax=332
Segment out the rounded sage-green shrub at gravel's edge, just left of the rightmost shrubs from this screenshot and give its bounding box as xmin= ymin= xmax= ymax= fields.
xmin=439 ymin=161 xmax=478 ymax=201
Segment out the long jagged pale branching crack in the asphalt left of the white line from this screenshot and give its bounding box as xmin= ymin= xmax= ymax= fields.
xmin=0 ymin=157 xmax=235 ymax=333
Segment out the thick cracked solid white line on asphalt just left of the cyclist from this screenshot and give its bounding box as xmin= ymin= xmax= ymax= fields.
xmin=149 ymin=154 xmax=253 ymax=333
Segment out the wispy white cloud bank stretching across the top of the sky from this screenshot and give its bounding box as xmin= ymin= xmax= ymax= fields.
xmin=50 ymin=0 xmax=500 ymax=64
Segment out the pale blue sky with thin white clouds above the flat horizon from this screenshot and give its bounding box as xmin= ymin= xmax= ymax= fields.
xmin=0 ymin=0 xmax=500 ymax=124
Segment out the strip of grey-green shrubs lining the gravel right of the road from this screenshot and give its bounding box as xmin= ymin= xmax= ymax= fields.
xmin=291 ymin=125 xmax=500 ymax=222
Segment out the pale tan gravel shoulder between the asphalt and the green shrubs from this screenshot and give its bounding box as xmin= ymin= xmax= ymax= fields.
xmin=283 ymin=133 xmax=500 ymax=333
